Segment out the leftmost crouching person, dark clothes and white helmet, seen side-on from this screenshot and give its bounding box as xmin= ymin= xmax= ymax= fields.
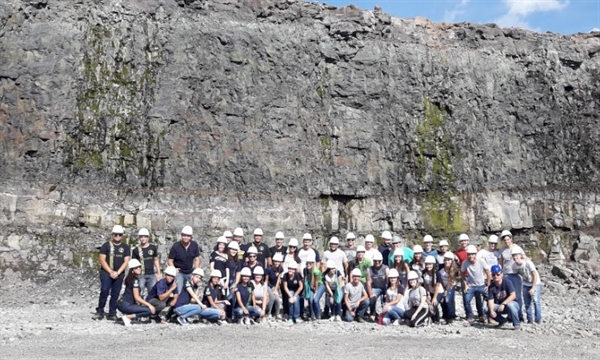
xmin=117 ymin=259 xmax=156 ymax=326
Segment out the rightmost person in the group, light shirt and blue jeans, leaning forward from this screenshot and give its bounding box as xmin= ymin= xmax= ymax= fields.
xmin=512 ymin=246 xmax=542 ymax=324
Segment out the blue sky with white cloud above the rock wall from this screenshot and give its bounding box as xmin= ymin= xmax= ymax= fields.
xmin=304 ymin=0 xmax=600 ymax=34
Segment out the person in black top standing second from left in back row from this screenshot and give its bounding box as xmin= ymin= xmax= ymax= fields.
xmin=131 ymin=228 xmax=162 ymax=294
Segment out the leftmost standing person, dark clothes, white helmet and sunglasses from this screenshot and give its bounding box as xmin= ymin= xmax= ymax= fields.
xmin=92 ymin=225 xmax=131 ymax=321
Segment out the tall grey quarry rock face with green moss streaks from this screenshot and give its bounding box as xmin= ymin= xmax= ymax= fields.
xmin=0 ymin=0 xmax=600 ymax=276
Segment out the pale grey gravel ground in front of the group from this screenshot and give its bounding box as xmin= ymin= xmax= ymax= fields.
xmin=0 ymin=268 xmax=600 ymax=359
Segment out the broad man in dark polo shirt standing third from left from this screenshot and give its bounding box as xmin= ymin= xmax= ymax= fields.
xmin=167 ymin=226 xmax=201 ymax=294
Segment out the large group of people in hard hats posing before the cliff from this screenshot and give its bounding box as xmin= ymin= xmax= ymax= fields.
xmin=93 ymin=225 xmax=542 ymax=329
